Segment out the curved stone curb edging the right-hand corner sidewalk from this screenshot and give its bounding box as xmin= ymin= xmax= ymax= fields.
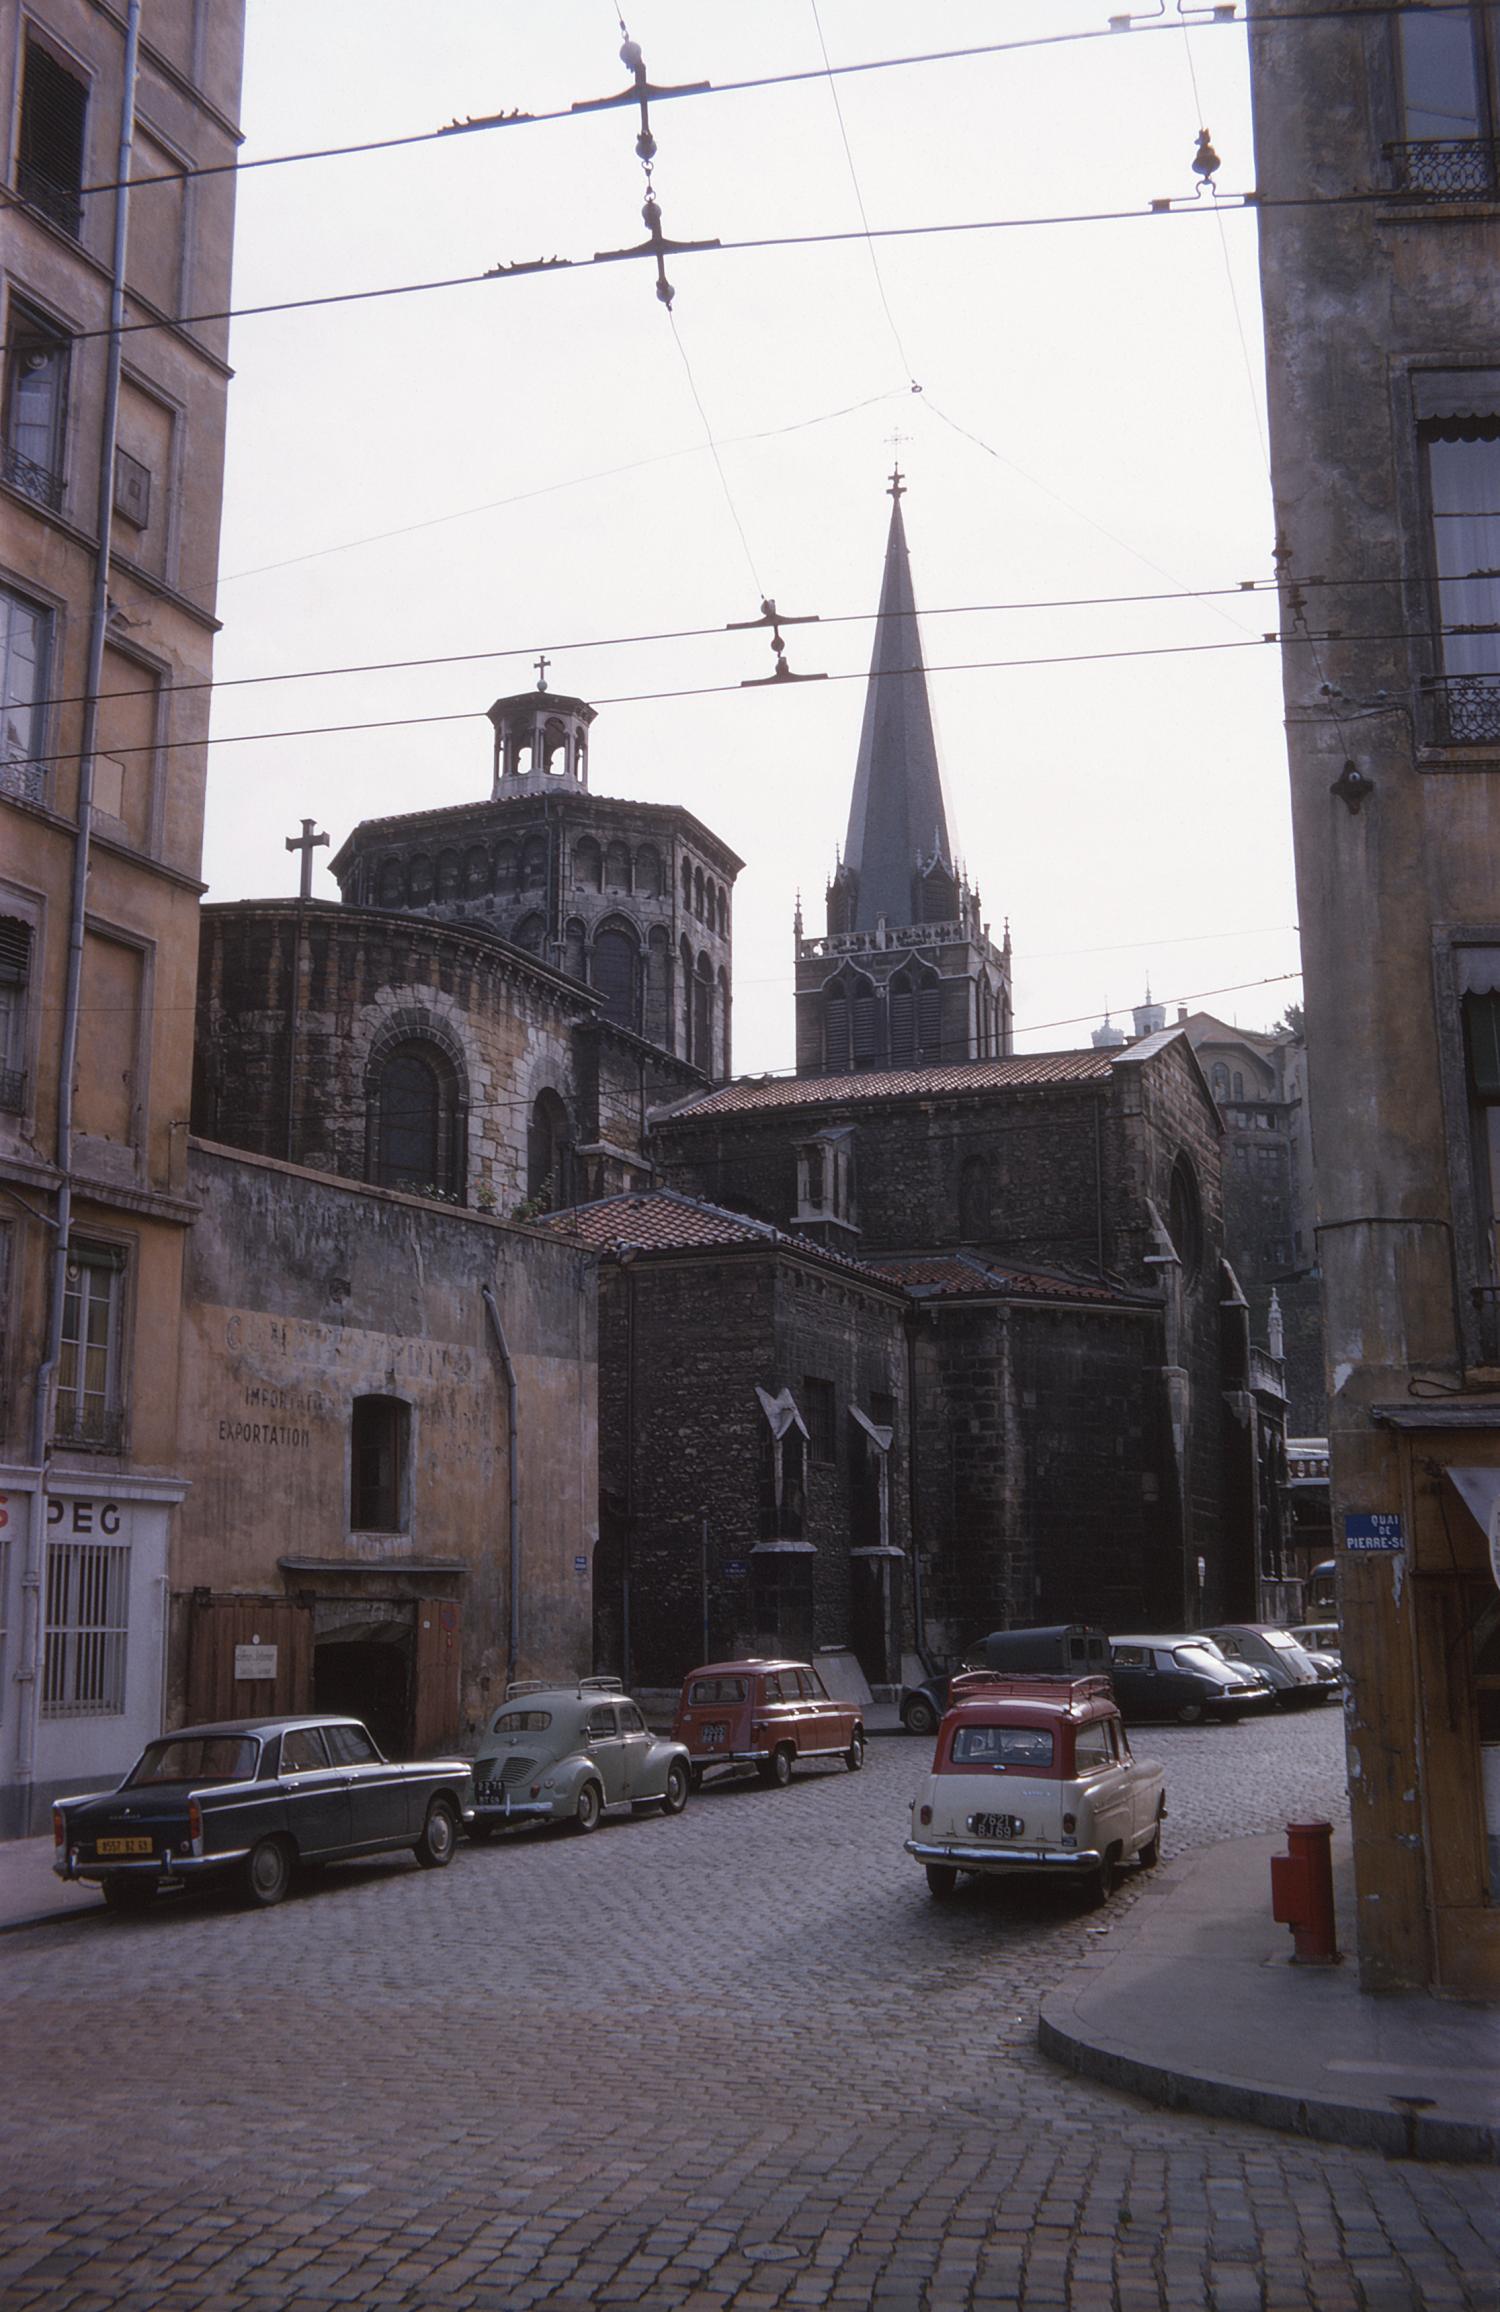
xmin=1035 ymin=2000 xmax=1500 ymax=2166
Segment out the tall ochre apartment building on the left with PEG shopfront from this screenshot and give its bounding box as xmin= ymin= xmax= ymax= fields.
xmin=0 ymin=0 xmax=243 ymax=1836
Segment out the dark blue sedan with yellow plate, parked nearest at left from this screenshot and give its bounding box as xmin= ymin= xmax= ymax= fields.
xmin=53 ymin=1716 xmax=474 ymax=1910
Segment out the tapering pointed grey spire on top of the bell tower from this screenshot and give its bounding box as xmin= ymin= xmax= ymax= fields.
xmin=844 ymin=467 xmax=952 ymax=932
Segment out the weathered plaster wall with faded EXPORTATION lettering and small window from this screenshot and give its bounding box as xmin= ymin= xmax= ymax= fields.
xmin=171 ymin=1142 xmax=596 ymax=1743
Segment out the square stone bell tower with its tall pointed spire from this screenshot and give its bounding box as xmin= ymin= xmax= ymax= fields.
xmin=795 ymin=483 xmax=1010 ymax=1075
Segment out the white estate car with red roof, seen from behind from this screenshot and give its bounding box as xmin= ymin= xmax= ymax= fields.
xmin=906 ymin=1669 xmax=1167 ymax=1903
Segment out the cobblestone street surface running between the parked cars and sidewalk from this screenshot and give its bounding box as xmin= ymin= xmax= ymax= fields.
xmin=0 ymin=1711 xmax=1500 ymax=2312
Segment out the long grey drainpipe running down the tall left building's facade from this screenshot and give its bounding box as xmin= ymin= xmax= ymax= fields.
xmin=16 ymin=0 xmax=141 ymax=1831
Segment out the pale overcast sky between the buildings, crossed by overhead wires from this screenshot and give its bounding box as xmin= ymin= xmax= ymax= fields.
xmin=203 ymin=0 xmax=1301 ymax=1073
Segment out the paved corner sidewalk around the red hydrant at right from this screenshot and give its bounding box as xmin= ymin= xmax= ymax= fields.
xmin=1038 ymin=1824 xmax=1500 ymax=2164
